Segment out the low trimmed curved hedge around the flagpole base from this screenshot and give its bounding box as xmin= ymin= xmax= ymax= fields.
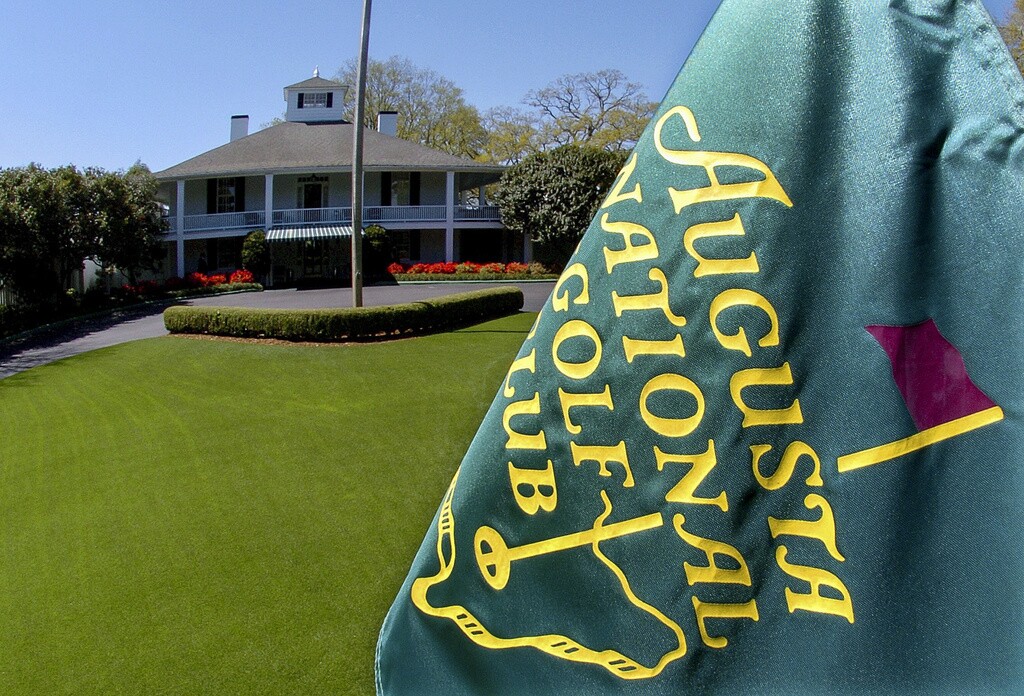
xmin=164 ymin=288 xmax=523 ymax=343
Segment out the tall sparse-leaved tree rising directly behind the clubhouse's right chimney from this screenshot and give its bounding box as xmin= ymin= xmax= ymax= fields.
xmin=337 ymin=55 xmax=487 ymax=157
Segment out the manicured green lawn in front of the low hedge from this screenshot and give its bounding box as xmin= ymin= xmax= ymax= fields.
xmin=0 ymin=313 xmax=535 ymax=694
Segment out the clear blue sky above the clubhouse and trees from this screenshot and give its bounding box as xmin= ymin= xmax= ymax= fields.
xmin=0 ymin=0 xmax=1012 ymax=170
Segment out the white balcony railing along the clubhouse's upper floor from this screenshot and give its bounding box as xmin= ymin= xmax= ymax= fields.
xmin=167 ymin=206 xmax=501 ymax=233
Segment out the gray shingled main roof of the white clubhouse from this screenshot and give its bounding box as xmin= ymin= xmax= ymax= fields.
xmin=156 ymin=122 xmax=503 ymax=181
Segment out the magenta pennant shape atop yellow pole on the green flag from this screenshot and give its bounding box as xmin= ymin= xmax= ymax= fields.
xmin=865 ymin=319 xmax=995 ymax=430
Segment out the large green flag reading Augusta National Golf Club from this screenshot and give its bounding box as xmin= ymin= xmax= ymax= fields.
xmin=377 ymin=0 xmax=1024 ymax=696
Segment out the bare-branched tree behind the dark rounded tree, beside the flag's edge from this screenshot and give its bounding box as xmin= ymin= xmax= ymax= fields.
xmin=523 ymin=70 xmax=657 ymax=150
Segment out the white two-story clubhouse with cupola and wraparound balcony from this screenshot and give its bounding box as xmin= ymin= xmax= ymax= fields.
xmin=156 ymin=72 xmax=530 ymax=285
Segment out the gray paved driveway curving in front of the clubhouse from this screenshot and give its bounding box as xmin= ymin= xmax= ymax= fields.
xmin=0 ymin=281 xmax=555 ymax=380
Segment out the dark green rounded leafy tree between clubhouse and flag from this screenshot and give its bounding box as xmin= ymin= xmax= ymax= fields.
xmin=494 ymin=144 xmax=626 ymax=267
